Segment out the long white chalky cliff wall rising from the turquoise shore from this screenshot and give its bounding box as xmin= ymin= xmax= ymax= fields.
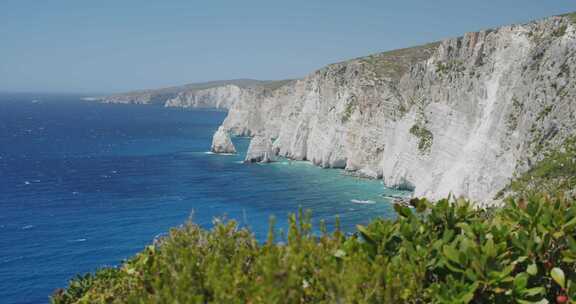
xmin=223 ymin=17 xmax=576 ymax=201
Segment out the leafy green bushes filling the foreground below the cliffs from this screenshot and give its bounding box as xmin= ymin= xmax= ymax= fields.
xmin=51 ymin=196 xmax=576 ymax=303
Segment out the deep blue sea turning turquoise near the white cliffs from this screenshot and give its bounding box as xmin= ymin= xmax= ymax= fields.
xmin=0 ymin=94 xmax=399 ymax=303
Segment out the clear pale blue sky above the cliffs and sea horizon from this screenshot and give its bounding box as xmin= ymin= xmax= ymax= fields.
xmin=0 ymin=0 xmax=576 ymax=92
